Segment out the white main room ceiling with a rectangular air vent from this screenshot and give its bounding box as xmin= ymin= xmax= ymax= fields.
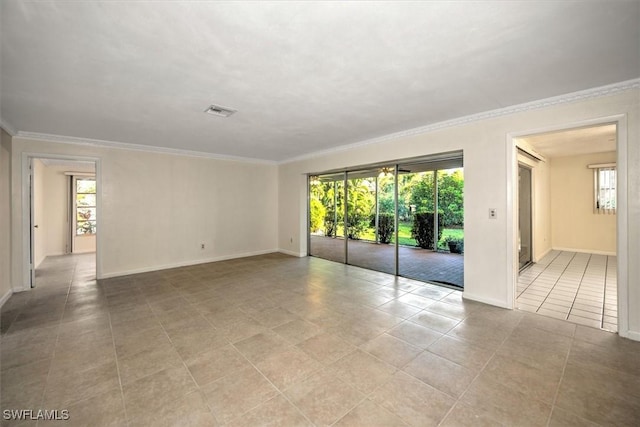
xmin=0 ymin=0 xmax=640 ymax=161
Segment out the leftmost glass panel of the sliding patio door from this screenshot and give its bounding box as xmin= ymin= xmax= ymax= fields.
xmin=309 ymin=173 xmax=346 ymax=262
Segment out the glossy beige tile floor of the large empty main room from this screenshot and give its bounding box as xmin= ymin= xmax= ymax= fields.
xmin=0 ymin=254 xmax=640 ymax=426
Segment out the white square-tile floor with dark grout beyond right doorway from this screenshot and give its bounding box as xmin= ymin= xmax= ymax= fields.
xmin=516 ymin=251 xmax=618 ymax=332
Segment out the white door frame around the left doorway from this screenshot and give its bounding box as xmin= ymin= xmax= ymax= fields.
xmin=20 ymin=152 xmax=102 ymax=291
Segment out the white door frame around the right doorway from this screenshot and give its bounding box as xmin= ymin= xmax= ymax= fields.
xmin=506 ymin=114 xmax=630 ymax=337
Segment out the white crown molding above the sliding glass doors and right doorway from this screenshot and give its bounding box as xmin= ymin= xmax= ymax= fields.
xmin=278 ymin=78 xmax=640 ymax=165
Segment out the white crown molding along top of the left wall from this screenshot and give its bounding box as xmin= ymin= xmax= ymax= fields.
xmin=14 ymin=131 xmax=277 ymax=165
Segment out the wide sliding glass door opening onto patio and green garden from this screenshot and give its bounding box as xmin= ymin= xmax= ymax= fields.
xmin=308 ymin=152 xmax=464 ymax=288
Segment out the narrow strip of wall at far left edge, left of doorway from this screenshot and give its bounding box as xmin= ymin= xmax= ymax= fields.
xmin=0 ymin=129 xmax=11 ymax=306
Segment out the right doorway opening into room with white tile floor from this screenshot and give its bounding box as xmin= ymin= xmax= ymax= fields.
xmin=515 ymin=123 xmax=622 ymax=331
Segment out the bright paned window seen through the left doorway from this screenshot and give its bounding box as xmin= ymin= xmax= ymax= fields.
xmin=71 ymin=176 xmax=97 ymax=253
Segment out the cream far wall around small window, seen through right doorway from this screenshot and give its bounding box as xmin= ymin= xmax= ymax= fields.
xmin=551 ymin=152 xmax=617 ymax=255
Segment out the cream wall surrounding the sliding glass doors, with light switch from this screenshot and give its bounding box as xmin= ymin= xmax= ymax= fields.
xmin=279 ymin=88 xmax=640 ymax=339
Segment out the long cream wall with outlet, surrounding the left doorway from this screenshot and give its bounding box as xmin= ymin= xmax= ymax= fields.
xmin=12 ymin=137 xmax=278 ymax=282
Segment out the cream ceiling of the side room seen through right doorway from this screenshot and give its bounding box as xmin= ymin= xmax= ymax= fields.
xmin=519 ymin=124 xmax=616 ymax=158
